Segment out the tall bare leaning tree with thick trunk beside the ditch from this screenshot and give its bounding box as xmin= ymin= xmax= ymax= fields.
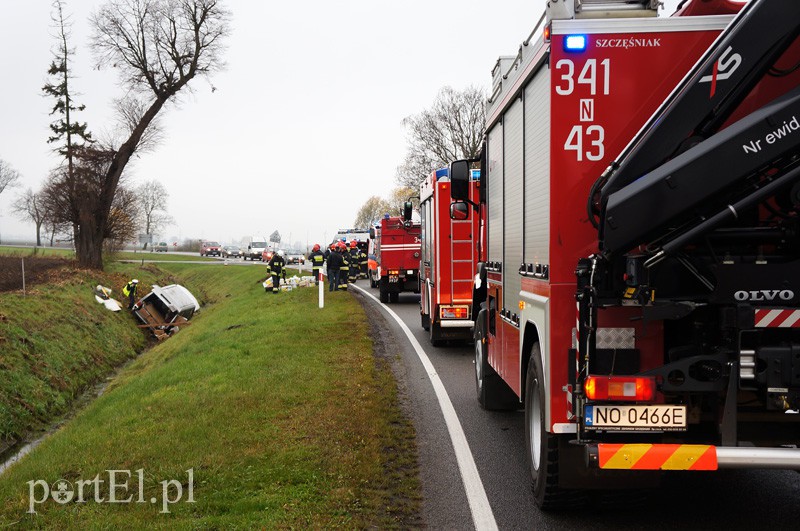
xmin=54 ymin=0 xmax=229 ymax=269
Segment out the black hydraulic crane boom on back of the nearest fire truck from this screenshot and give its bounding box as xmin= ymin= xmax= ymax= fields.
xmin=590 ymin=0 xmax=800 ymax=256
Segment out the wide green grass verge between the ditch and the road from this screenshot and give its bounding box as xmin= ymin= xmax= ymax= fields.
xmin=0 ymin=264 xmax=418 ymax=528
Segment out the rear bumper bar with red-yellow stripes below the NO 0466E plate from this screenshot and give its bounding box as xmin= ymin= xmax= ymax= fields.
xmin=586 ymin=443 xmax=800 ymax=470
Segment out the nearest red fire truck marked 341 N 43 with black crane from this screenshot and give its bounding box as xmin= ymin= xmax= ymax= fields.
xmin=450 ymin=0 xmax=800 ymax=508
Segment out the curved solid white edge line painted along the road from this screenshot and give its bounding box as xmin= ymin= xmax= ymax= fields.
xmin=350 ymin=284 xmax=497 ymax=530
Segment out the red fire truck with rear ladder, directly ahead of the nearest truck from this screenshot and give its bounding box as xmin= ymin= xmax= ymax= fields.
xmin=419 ymin=168 xmax=480 ymax=345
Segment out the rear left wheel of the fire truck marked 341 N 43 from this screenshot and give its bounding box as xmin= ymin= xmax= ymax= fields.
xmin=525 ymin=343 xmax=582 ymax=509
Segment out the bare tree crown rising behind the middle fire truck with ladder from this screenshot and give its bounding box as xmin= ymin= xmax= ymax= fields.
xmin=396 ymin=87 xmax=486 ymax=190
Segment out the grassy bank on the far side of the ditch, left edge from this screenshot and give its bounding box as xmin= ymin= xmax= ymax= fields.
xmin=0 ymin=267 xmax=146 ymax=448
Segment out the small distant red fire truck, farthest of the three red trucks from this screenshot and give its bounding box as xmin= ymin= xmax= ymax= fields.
xmin=370 ymin=203 xmax=420 ymax=302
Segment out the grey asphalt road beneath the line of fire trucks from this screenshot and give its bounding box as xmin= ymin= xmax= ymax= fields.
xmin=350 ymin=286 xmax=800 ymax=530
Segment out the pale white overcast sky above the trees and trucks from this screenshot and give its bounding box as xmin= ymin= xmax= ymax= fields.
xmin=0 ymin=0 xmax=678 ymax=249
